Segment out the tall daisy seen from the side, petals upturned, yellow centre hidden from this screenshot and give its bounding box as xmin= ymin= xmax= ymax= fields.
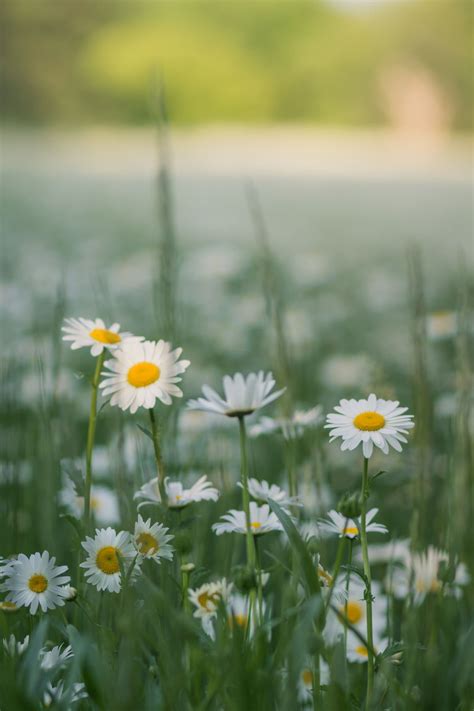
xmin=188 ymin=370 xmax=285 ymax=417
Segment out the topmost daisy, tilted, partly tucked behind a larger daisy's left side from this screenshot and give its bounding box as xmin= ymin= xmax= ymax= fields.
xmin=61 ymin=318 xmax=139 ymax=356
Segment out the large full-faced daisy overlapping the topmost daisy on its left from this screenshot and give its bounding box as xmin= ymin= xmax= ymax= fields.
xmin=99 ymin=340 xmax=190 ymax=414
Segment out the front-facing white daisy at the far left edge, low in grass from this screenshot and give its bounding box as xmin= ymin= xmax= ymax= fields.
xmin=0 ymin=551 xmax=70 ymax=615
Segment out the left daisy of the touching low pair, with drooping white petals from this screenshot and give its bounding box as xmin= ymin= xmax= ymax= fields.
xmin=81 ymin=528 xmax=138 ymax=593
